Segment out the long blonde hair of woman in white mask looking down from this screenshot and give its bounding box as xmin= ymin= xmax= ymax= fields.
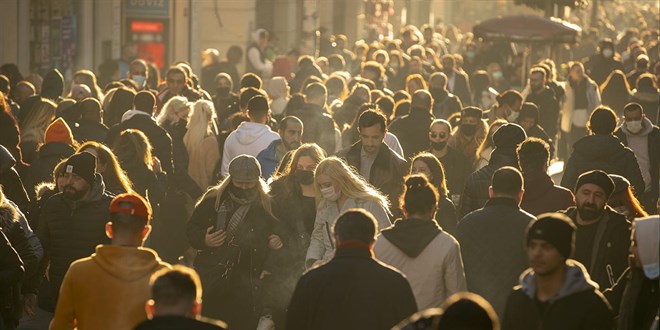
xmin=314 ymin=156 xmax=390 ymax=209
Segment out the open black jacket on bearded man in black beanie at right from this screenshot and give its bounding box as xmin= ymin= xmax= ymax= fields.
xmin=564 ymin=206 xmax=630 ymax=290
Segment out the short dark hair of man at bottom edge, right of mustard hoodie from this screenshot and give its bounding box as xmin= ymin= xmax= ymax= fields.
xmin=151 ymin=265 xmax=202 ymax=307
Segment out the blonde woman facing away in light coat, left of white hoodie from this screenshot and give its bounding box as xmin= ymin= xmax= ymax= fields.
xmin=183 ymin=100 xmax=220 ymax=190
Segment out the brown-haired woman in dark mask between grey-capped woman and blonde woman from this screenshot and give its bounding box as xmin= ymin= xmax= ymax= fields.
xmin=264 ymin=144 xmax=325 ymax=326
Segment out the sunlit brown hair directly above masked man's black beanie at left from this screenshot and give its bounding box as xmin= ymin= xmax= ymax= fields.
xmin=76 ymin=141 xmax=133 ymax=195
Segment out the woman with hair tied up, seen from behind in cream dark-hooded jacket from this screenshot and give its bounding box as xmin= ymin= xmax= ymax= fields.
xmin=374 ymin=175 xmax=466 ymax=310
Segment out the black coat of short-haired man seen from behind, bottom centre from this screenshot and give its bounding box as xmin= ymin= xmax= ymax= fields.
xmin=286 ymin=248 xmax=417 ymax=330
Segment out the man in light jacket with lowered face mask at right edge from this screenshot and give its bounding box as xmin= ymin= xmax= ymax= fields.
xmin=614 ymin=103 xmax=660 ymax=215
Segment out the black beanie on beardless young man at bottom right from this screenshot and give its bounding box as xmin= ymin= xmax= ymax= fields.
xmin=526 ymin=213 xmax=575 ymax=259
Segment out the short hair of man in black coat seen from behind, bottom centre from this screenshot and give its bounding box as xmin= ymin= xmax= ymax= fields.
xmin=333 ymin=209 xmax=378 ymax=244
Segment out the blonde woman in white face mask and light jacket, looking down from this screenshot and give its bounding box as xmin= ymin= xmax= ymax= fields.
xmin=306 ymin=157 xmax=391 ymax=267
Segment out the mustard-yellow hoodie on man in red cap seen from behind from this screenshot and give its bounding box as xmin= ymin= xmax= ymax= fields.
xmin=50 ymin=245 xmax=171 ymax=329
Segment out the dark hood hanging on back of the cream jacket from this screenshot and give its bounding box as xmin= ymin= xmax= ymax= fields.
xmin=381 ymin=219 xmax=442 ymax=258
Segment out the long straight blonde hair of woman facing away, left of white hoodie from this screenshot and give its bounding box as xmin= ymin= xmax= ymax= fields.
xmin=183 ymin=100 xmax=217 ymax=155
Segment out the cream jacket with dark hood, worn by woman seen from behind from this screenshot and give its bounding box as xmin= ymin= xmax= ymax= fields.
xmin=374 ymin=219 xmax=466 ymax=310
